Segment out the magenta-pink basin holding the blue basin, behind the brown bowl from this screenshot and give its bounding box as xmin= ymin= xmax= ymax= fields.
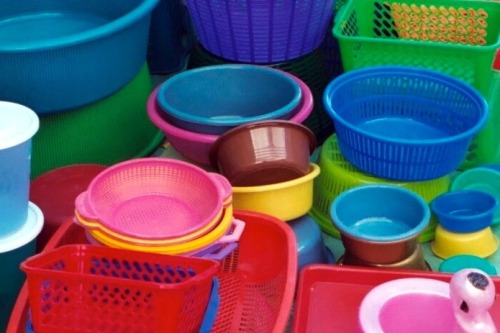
xmin=147 ymin=73 xmax=314 ymax=166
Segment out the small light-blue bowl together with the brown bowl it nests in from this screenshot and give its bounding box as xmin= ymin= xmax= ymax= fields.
xmin=330 ymin=184 xmax=430 ymax=264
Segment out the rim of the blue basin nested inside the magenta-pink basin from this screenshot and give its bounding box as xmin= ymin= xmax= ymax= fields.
xmin=156 ymin=64 xmax=302 ymax=126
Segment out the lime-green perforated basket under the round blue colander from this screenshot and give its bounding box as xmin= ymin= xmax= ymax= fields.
xmin=309 ymin=134 xmax=450 ymax=242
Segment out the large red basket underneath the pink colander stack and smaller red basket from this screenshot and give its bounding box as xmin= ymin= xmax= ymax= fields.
xmin=7 ymin=210 xmax=297 ymax=333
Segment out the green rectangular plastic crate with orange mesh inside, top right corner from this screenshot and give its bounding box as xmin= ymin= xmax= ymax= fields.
xmin=332 ymin=0 xmax=500 ymax=169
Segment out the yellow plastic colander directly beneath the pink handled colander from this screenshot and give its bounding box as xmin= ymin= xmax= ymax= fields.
xmin=88 ymin=205 xmax=233 ymax=255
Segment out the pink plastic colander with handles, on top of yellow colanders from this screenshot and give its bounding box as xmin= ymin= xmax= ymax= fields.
xmin=75 ymin=157 xmax=232 ymax=240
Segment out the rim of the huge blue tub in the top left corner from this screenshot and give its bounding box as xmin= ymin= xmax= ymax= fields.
xmin=0 ymin=0 xmax=160 ymax=53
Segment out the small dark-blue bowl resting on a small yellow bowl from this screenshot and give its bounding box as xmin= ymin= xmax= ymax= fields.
xmin=431 ymin=190 xmax=498 ymax=233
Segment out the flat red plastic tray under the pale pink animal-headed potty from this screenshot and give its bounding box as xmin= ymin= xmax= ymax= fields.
xmin=293 ymin=265 xmax=500 ymax=333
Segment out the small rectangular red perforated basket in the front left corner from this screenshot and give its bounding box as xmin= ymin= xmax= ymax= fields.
xmin=21 ymin=245 xmax=219 ymax=333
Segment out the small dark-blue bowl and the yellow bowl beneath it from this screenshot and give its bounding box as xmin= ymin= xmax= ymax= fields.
xmin=431 ymin=190 xmax=499 ymax=259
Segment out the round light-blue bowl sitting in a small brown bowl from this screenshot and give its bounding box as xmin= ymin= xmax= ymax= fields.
xmin=330 ymin=185 xmax=430 ymax=242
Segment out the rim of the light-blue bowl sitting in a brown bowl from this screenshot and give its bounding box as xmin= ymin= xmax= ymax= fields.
xmin=330 ymin=184 xmax=431 ymax=242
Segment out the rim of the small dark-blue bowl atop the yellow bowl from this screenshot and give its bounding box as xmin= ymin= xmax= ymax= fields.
xmin=430 ymin=190 xmax=498 ymax=221
